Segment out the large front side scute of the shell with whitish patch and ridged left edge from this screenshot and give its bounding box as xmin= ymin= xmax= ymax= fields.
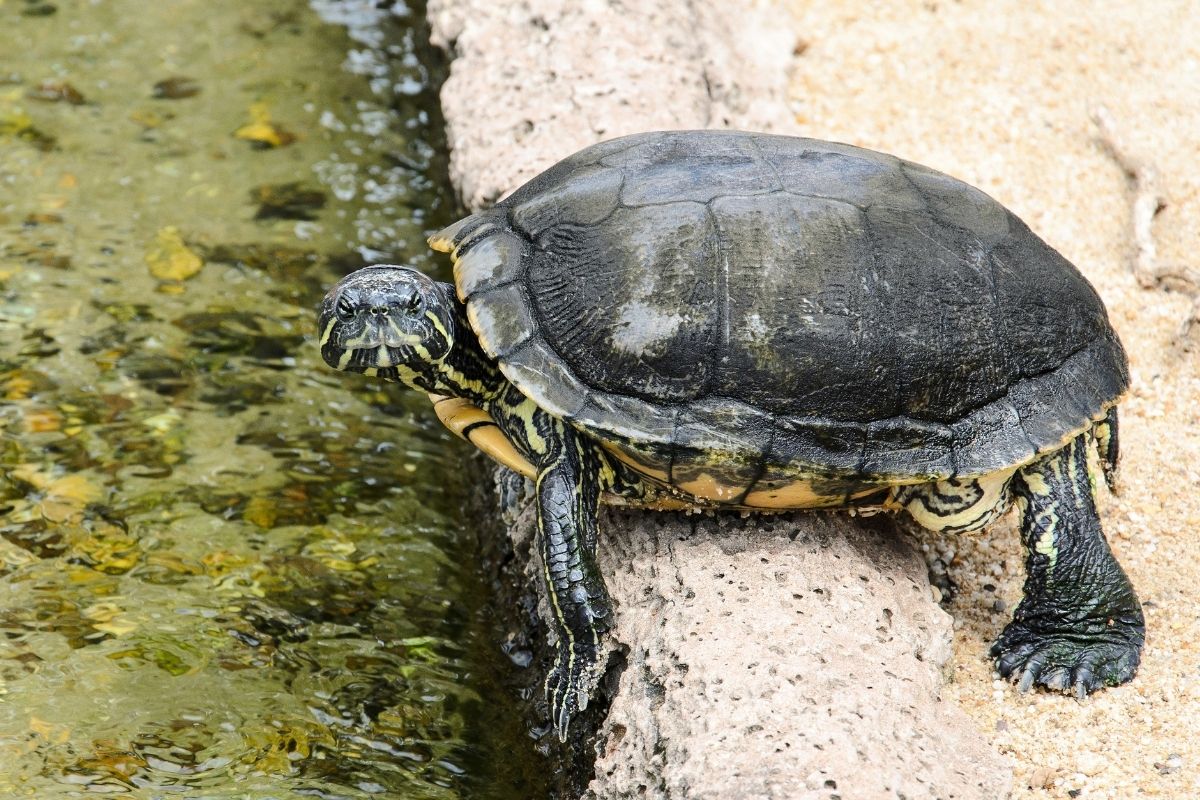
xmin=528 ymin=203 xmax=720 ymax=403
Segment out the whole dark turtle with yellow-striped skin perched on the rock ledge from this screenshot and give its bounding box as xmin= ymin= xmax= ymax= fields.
xmin=318 ymin=131 xmax=1145 ymax=738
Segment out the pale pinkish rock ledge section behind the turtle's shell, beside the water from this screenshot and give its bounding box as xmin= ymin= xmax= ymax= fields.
xmin=428 ymin=0 xmax=794 ymax=209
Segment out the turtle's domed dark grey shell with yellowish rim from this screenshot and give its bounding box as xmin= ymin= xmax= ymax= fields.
xmin=431 ymin=131 xmax=1128 ymax=494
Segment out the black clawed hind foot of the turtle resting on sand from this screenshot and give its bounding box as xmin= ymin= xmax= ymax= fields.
xmin=991 ymin=608 xmax=1146 ymax=698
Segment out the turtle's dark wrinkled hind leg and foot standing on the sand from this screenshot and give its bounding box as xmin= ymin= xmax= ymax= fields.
xmin=991 ymin=434 xmax=1146 ymax=697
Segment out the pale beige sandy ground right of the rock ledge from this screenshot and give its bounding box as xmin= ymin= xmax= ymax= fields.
xmin=784 ymin=0 xmax=1200 ymax=799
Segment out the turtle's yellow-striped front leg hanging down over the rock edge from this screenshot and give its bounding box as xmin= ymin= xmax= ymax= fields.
xmin=536 ymin=425 xmax=612 ymax=741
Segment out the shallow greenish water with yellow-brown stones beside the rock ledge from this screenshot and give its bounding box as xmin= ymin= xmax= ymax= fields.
xmin=0 ymin=0 xmax=546 ymax=799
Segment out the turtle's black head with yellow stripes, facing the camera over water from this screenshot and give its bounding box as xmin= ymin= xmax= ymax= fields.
xmin=317 ymin=264 xmax=456 ymax=391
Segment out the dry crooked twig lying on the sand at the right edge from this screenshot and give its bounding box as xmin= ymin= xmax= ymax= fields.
xmin=1092 ymin=106 xmax=1200 ymax=349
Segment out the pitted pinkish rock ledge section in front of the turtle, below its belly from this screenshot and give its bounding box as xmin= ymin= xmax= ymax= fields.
xmin=590 ymin=513 xmax=1007 ymax=799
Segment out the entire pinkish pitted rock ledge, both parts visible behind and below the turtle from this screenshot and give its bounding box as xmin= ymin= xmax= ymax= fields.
xmin=428 ymin=0 xmax=1010 ymax=800
